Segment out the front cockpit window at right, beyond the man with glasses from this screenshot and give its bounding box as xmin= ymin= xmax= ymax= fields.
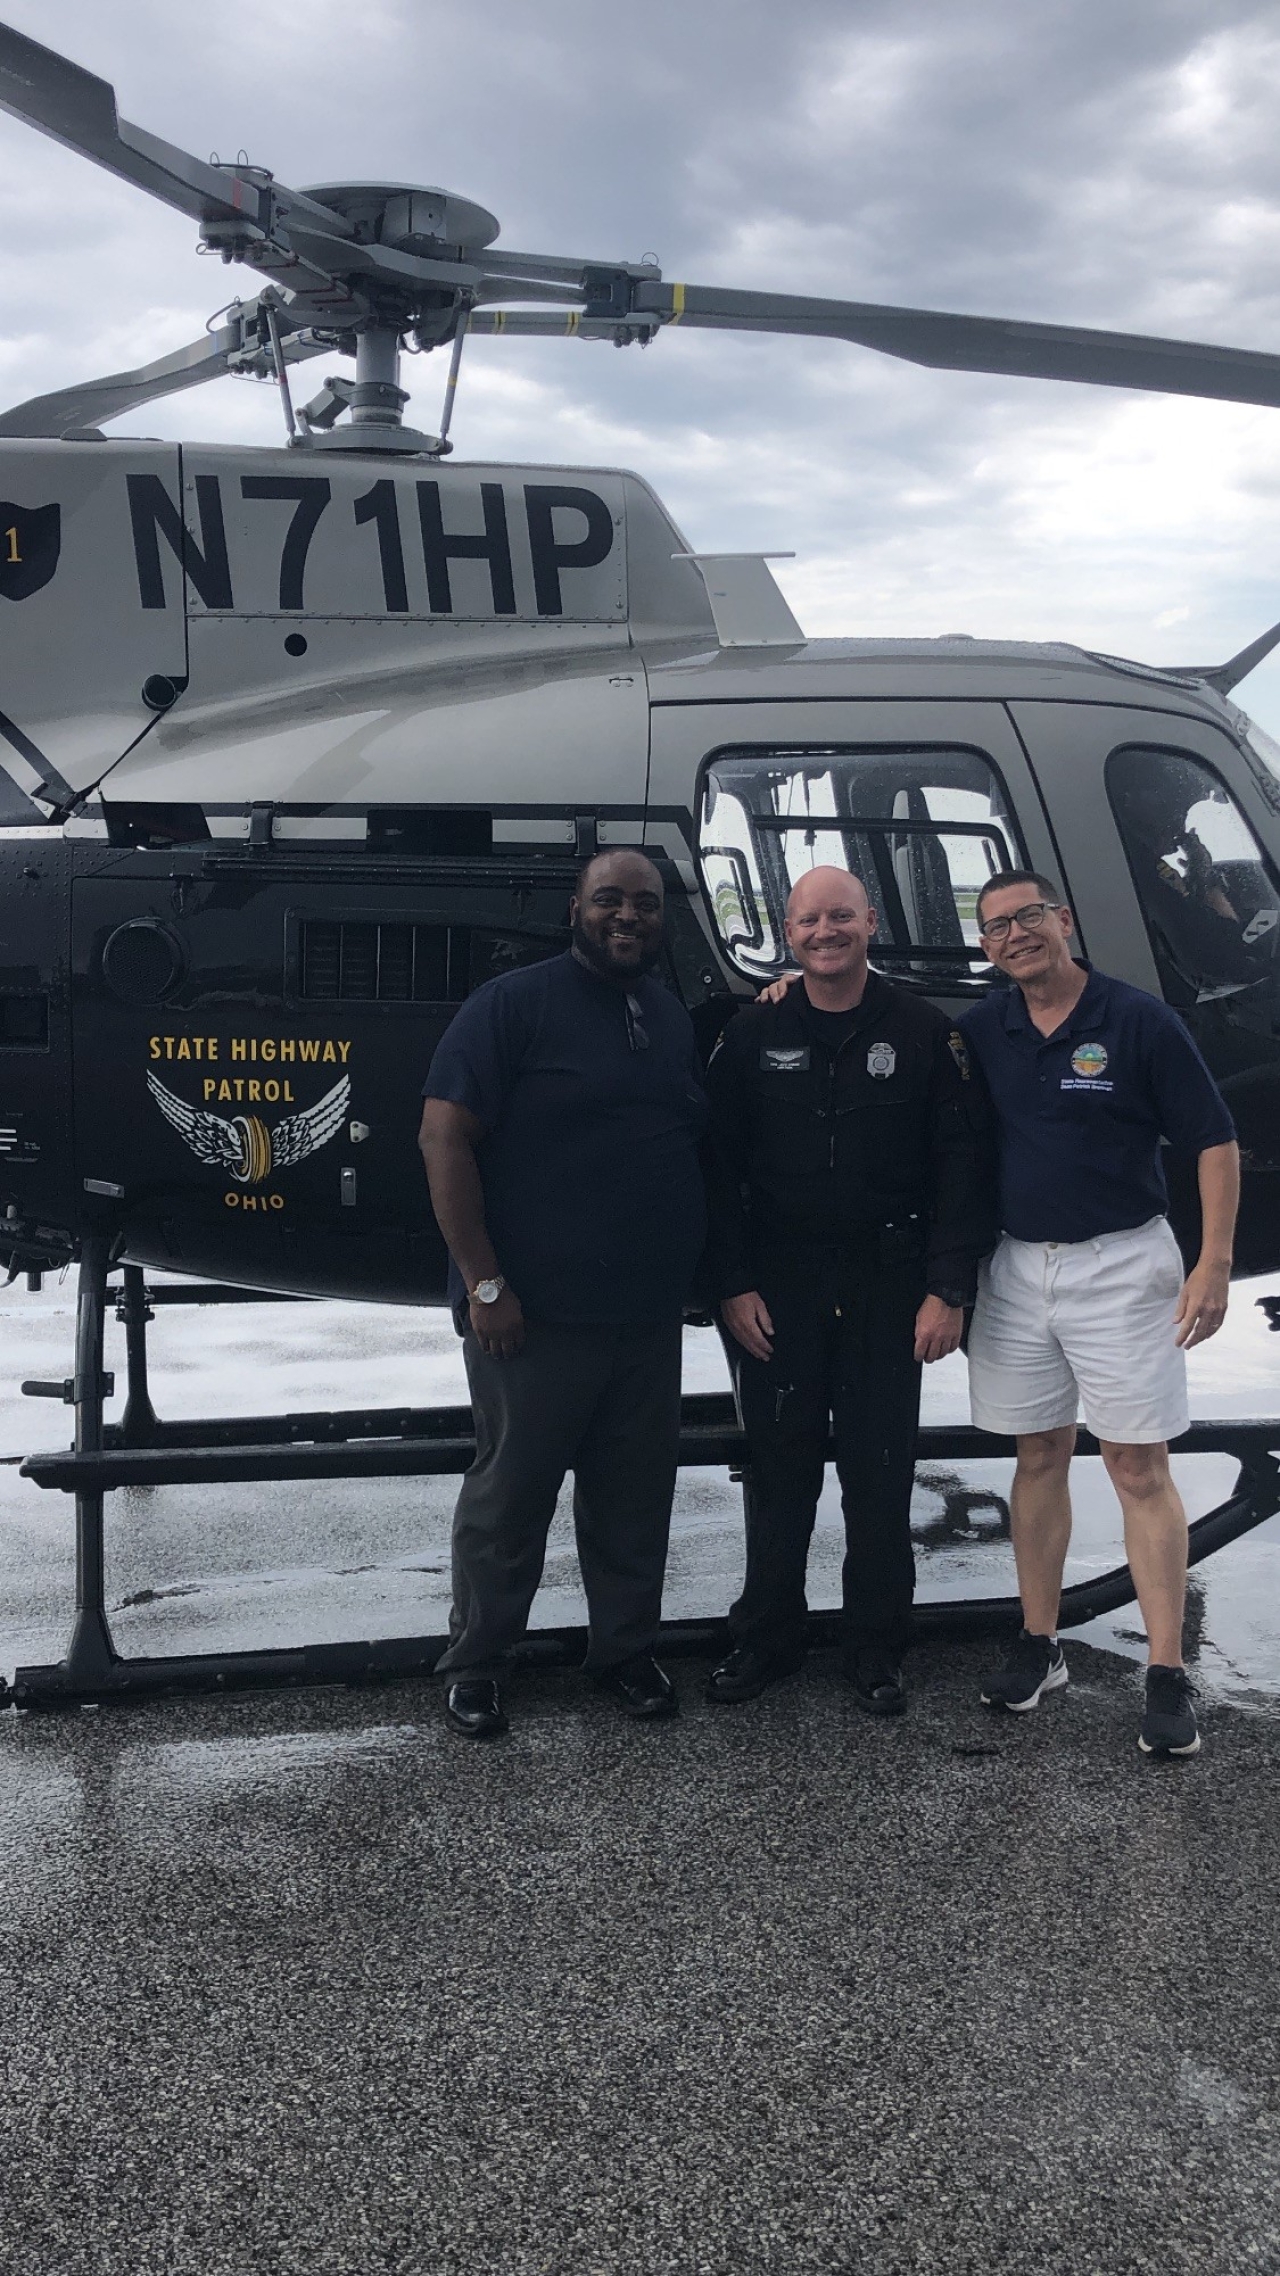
xmin=1107 ymin=744 xmax=1280 ymax=1008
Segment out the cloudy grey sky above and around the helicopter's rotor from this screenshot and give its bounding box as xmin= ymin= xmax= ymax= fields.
xmin=0 ymin=0 xmax=1280 ymax=733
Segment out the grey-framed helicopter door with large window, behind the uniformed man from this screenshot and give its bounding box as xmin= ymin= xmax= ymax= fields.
xmin=649 ymin=699 xmax=1055 ymax=1001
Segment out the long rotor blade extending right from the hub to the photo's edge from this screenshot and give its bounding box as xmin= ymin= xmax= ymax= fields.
xmin=631 ymin=285 xmax=1280 ymax=405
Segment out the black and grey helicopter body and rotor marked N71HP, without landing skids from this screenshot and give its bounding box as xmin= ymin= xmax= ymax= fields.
xmin=0 ymin=13 xmax=1280 ymax=1302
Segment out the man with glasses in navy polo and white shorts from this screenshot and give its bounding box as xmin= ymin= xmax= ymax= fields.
xmin=961 ymin=869 xmax=1239 ymax=1755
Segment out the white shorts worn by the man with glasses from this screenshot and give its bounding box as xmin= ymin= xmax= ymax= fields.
xmin=968 ymin=1218 xmax=1191 ymax=1445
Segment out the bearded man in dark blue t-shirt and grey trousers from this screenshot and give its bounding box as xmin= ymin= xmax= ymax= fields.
xmin=419 ymin=851 xmax=706 ymax=1739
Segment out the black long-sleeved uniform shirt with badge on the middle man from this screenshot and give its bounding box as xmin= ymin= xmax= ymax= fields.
xmin=708 ymin=972 xmax=995 ymax=1304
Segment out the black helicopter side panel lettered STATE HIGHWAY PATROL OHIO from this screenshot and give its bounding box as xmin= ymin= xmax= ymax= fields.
xmin=73 ymin=851 xmax=572 ymax=1302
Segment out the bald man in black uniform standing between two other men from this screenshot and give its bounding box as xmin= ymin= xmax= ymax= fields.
xmin=708 ymin=869 xmax=995 ymax=1714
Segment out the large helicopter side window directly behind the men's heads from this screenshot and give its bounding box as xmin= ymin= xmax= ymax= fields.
xmin=699 ymin=749 xmax=1023 ymax=992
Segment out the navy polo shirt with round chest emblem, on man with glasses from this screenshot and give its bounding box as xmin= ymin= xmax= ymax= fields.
xmin=961 ymin=965 xmax=1234 ymax=1240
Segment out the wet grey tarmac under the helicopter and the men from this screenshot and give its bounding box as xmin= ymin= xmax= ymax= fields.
xmin=0 ymin=1286 xmax=1280 ymax=2276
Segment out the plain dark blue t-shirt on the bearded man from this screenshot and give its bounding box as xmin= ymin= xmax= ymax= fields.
xmin=424 ymin=954 xmax=706 ymax=1327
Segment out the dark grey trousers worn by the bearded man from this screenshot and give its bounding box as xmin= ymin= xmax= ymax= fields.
xmin=437 ymin=1320 xmax=681 ymax=1675
